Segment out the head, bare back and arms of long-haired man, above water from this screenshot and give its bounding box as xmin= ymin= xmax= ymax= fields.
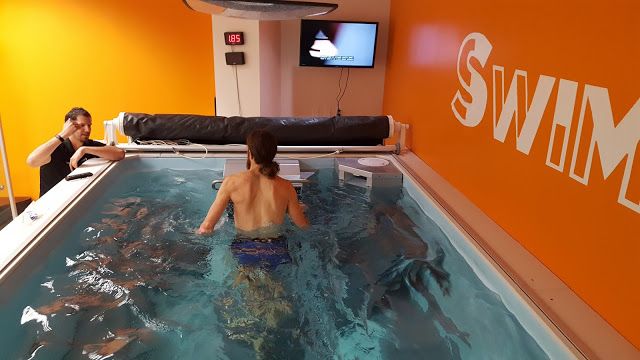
xmin=198 ymin=130 xmax=309 ymax=237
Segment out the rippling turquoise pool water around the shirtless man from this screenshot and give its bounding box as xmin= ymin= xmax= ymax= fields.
xmin=0 ymin=169 xmax=548 ymax=359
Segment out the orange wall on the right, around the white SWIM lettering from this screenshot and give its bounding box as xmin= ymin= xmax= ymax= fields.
xmin=384 ymin=0 xmax=640 ymax=347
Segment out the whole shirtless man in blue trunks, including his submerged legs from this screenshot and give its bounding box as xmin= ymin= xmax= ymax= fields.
xmin=198 ymin=130 xmax=309 ymax=359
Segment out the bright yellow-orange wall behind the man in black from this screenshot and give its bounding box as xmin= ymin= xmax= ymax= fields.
xmin=0 ymin=0 xmax=214 ymax=198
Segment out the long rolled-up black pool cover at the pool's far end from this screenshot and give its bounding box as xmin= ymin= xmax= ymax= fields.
xmin=123 ymin=113 xmax=389 ymax=146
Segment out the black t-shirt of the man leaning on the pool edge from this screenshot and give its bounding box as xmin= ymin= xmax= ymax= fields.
xmin=40 ymin=139 xmax=104 ymax=196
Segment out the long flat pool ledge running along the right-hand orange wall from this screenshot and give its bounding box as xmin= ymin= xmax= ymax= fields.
xmin=392 ymin=152 xmax=640 ymax=360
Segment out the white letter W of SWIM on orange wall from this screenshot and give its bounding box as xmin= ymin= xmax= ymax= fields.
xmin=493 ymin=65 xmax=556 ymax=155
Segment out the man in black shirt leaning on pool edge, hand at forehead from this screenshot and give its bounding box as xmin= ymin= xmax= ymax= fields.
xmin=27 ymin=108 xmax=124 ymax=196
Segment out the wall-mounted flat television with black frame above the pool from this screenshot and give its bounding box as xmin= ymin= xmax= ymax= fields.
xmin=300 ymin=20 xmax=378 ymax=68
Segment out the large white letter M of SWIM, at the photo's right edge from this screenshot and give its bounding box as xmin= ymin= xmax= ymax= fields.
xmin=569 ymin=84 xmax=640 ymax=213
